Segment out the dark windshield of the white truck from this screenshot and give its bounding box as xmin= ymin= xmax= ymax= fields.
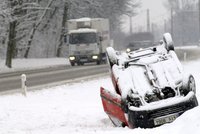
xmin=69 ymin=33 xmax=97 ymax=44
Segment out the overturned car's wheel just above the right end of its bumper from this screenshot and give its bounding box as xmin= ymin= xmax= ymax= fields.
xmin=182 ymin=74 xmax=196 ymax=95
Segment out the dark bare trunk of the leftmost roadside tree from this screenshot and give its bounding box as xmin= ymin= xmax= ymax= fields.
xmin=5 ymin=21 xmax=17 ymax=68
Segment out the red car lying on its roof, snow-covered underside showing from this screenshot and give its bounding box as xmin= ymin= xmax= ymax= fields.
xmin=100 ymin=33 xmax=198 ymax=128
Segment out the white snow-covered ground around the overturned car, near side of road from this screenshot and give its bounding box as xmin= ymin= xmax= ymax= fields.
xmin=0 ymin=60 xmax=200 ymax=134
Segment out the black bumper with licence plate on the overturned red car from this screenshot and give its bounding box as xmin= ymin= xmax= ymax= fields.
xmin=128 ymin=92 xmax=198 ymax=128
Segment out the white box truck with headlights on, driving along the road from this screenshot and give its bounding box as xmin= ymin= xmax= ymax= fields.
xmin=66 ymin=18 xmax=110 ymax=66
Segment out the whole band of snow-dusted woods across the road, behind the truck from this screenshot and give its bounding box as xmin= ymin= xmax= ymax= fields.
xmin=0 ymin=0 xmax=139 ymax=68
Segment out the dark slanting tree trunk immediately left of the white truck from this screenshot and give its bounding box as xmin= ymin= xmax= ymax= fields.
xmin=56 ymin=2 xmax=68 ymax=57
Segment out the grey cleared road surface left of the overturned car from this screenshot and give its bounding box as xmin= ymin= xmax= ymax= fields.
xmin=0 ymin=65 xmax=109 ymax=92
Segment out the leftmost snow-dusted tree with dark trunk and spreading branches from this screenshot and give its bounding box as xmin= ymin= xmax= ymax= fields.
xmin=0 ymin=0 xmax=47 ymax=68
